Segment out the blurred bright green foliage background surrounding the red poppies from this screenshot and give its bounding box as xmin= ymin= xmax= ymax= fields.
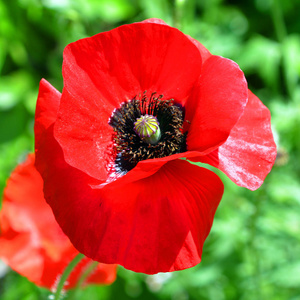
xmin=0 ymin=0 xmax=300 ymax=300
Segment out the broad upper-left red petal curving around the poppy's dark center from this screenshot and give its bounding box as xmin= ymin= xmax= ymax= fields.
xmin=54 ymin=23 xmax=201 ymax=180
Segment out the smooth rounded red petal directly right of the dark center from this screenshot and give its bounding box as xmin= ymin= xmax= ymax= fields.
xmin=187 ymin=55 xmax=248 ymax=153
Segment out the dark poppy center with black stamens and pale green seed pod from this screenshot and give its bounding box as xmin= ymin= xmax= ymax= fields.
xmin=109 ymin=92 xmax=186 ymax=175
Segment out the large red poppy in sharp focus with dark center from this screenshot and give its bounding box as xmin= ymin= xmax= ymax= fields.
xmin=35 ymin=19 xmax=276 ymax=274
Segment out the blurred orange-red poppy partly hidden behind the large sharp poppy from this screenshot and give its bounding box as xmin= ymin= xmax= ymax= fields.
xmin=0 ymin=155 xmax=116 ymax=289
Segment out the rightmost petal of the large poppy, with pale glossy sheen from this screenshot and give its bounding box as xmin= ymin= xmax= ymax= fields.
xmin=195 ymin=91 xmax=276 ymax=190
